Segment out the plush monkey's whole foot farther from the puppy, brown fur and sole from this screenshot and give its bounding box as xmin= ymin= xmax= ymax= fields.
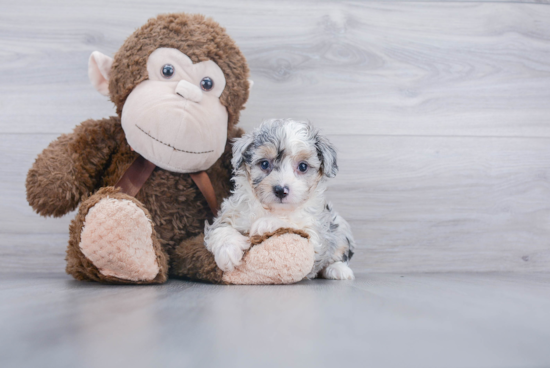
xmin=67 ymin=188 xmax=167 ymax=284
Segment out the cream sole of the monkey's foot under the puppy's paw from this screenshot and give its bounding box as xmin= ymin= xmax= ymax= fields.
xmin=223 ymin=233 xmax=314 ymax=285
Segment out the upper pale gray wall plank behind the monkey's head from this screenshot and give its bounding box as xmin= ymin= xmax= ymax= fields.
xmin=0 ymin=1 xmax=550 ymax=137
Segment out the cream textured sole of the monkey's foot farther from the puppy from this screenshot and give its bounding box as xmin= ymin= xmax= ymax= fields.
xmin=80 ymin=198 xmax=159 ymax=281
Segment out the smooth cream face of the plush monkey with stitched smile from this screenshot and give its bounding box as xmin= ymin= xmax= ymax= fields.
xmin=121 ymin=48 xmax=228 ymax=173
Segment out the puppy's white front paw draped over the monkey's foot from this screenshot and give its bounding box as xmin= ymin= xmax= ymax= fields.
xmin=204 ymin=225 xmax=250 ymax=271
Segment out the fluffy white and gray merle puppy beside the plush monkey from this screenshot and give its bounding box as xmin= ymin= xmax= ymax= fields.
xmin=205 ymin=119 xmax=355 ymax=280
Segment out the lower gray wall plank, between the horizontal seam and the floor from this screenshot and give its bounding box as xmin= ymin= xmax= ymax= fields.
xmin=0 ymin=135 xmax=550 ymax=272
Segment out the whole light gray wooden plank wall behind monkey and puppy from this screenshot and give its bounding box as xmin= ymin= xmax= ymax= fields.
xmin=0 ymin=0 xmax=550 ymax=272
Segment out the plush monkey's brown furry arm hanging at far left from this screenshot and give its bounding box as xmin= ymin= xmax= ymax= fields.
xmin=26 ymin=117 xmax=124 ymax=217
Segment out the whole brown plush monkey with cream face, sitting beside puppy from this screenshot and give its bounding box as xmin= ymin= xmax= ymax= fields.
xmin=26 ymin=13 xmax=313 ymax=284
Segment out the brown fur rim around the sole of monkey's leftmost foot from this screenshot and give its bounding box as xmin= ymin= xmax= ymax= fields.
xmin=66 ymin=187 xmax=168 ymax=284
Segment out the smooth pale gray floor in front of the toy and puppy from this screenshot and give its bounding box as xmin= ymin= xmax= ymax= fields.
xmin=0 ymin=272 xmax=550 ymax=368
